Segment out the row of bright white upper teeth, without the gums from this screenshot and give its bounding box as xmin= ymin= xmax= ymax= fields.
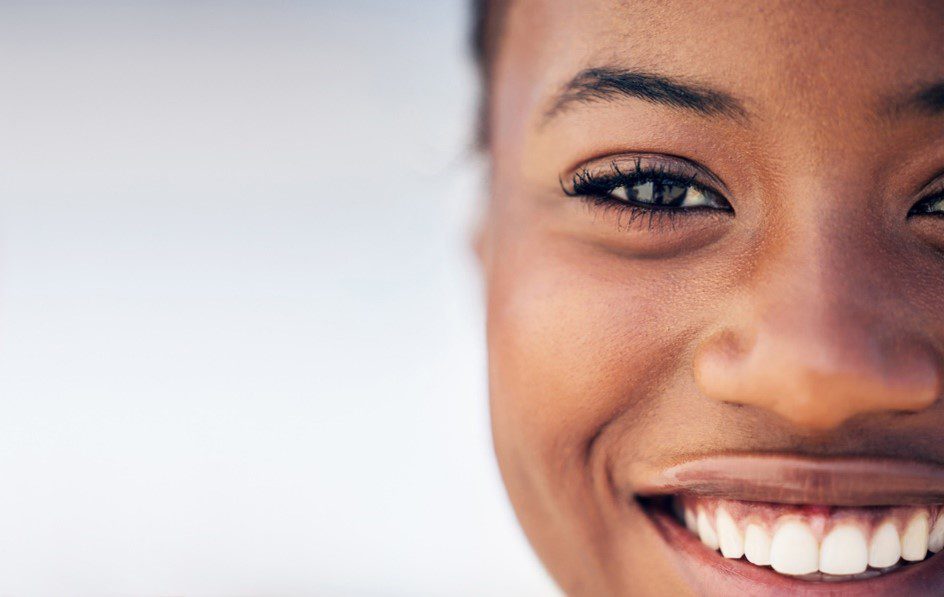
xmin=684 ymin=506 xmax=944 ymax=575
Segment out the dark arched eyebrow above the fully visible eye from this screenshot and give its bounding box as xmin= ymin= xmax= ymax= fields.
xmin=545 ymin=68 xmax=748 ymax=122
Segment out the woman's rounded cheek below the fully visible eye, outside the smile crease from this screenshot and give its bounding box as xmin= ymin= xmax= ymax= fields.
xmin=488 ymin=230 xmax=684 ymax=484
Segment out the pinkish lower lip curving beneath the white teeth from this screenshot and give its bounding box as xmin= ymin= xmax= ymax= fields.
xmin=644 ymin=500 xmax=944 ymax=597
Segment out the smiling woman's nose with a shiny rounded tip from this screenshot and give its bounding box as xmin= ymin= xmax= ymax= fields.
xmin=693 ymin=217 xmax=941 ymax=430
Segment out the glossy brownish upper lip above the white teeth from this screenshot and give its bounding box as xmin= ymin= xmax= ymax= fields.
xmin=633 ymin=454 xmax=944 ymax=506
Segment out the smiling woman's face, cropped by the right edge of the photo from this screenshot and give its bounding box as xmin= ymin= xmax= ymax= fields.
xmin=480 ymin=0 xmax=944 ymax=595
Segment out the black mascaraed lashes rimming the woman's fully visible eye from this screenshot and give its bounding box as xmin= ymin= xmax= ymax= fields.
xmin=560 ymin=158 xmax=734 ymax=230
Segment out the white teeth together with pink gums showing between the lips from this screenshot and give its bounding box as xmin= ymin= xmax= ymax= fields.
xmin=672 ymin=496 xmax=944 ymax=581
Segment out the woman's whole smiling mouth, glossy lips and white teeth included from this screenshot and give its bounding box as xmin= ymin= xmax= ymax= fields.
xmin=633 ymin=455 xmax=944 ymax=594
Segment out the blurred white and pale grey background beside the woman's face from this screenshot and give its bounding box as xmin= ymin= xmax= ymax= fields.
xmin=0 ymin=0 xmax=555 ymax=596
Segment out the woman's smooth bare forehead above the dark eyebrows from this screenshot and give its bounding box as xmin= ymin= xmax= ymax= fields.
xmin=494 ymin=0 xmax=944 ymax=142
